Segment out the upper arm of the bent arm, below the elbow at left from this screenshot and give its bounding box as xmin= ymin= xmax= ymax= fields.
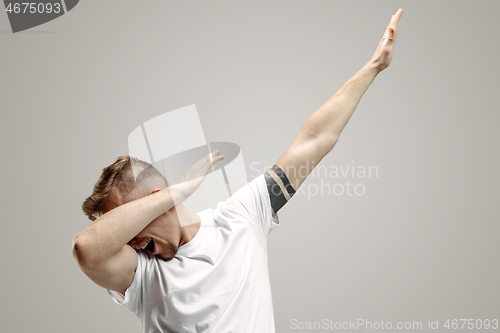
xmin=73 ymin=235 xmax=138 ymax=295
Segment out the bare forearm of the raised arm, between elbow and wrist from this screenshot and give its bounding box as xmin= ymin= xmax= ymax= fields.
xmin=300 ymin=63 xmax=380 ymax=153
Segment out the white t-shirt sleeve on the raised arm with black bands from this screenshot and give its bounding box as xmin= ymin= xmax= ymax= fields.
xmin=223 ymin=174 xmax=280 ymax=237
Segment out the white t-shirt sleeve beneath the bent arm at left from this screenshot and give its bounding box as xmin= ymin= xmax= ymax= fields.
xmin=108 ymin=251 xmax=147 ymax=316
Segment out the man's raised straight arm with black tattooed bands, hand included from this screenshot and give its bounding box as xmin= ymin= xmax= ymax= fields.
xmin=265 ymin=9 xmax=403 ymax=215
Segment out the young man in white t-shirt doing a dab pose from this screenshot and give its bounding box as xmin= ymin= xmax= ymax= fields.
xmin=73 ymin=9 xmax=402 ymax=333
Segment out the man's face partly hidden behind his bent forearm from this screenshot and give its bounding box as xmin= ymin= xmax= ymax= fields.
xmin=102 ymin=192 xmax=181 ymax=261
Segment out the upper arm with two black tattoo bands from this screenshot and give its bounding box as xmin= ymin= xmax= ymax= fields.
xmin=266 ymin=132 xmax=331 ymax=215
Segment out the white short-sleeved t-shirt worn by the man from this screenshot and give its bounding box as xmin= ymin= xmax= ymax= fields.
xmin=108 ymin=175 xmax=279 ymax=333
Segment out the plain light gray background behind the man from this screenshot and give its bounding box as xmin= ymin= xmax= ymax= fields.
xmin=0 ymin=0 xmax=500 ymax=332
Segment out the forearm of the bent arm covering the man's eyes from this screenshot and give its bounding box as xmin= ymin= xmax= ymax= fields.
xmin=73 ymin=185 xmax=183 ymax=265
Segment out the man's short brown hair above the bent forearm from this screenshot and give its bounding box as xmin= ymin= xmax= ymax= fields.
xmin=82 ymin=156 xmax=168 ymax=221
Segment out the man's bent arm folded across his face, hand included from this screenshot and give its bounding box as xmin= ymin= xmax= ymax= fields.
xmin=72 ymin=151 xmax=224 ymax=294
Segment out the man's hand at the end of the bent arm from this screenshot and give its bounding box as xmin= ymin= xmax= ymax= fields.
xmin=174 ymin=150 xmax=224 ymax=205
